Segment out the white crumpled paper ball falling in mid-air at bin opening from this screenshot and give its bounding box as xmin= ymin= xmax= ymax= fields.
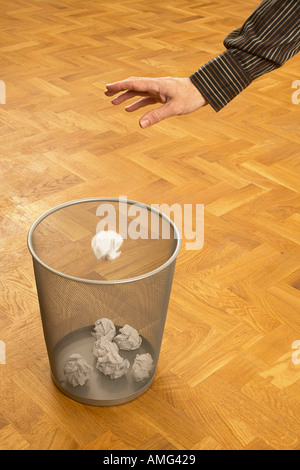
xmin=92 ymin=230 xmax=123 ymax=260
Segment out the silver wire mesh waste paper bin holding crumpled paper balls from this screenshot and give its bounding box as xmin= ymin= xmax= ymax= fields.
xmin=28 ymin=198 xmax=181 ymax=406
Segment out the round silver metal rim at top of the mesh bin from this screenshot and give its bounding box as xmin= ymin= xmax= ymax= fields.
xmin=27 ymin=197 xmax=181 ymax=285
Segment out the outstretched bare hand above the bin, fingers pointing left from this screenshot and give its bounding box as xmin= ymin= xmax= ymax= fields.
xmin=105 ymin=77 xmax=207 ymax=128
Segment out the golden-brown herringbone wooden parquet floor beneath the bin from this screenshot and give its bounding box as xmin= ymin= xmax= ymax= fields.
xmin=0 ymin=0 xmax=300 ymax=450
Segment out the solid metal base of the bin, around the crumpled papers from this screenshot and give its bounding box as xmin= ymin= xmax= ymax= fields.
xmin=50 ymin=325 xmax=157 ymax=406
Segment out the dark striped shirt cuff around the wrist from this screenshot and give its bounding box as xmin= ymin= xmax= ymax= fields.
xmin=190 ymin=50 xmax=252 ymax=111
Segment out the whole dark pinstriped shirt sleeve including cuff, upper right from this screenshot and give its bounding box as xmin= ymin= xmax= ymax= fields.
xmin=190 ymin=0 xmax=300 ymax=111
